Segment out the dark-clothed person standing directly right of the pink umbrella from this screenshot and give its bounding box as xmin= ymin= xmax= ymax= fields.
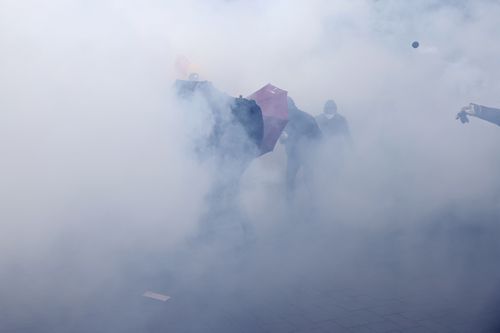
xmin=281 ymin=97 xmax=322 ymax=198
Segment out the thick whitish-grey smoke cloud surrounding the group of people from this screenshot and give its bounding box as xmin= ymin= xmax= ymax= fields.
xmin=0 ymin=0 xmax=500 ymax=331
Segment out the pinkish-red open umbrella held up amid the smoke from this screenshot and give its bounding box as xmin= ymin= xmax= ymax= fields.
xmin=247 ymin=84 xmax=288 ymax=155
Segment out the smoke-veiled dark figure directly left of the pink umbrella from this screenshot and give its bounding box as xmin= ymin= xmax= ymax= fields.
xmin=175 ymin=80 xmax=264 ymax=218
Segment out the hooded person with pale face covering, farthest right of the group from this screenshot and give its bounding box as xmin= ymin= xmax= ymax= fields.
xmin=316 ymin=99 xmax=351 ymax=141
